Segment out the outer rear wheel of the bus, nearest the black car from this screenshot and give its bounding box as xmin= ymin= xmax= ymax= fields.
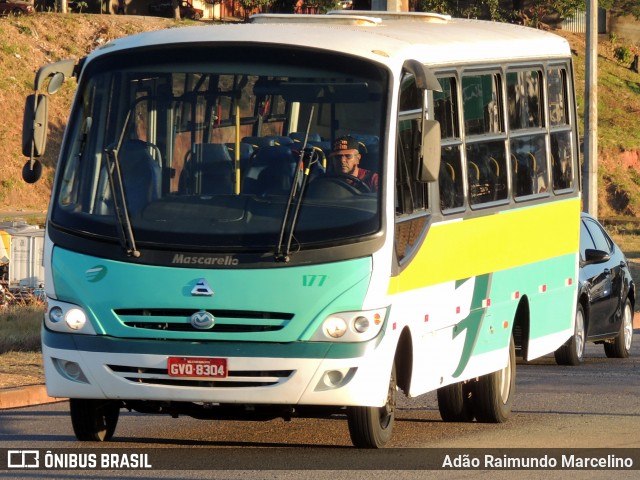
xmin=471 ymin=337 xmax=516 ymax=423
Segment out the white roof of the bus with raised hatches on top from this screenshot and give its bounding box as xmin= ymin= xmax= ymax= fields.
xmin=91 ymin=11 xmax=571 ymax=69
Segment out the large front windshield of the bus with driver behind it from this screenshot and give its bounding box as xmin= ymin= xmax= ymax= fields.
xmin=51 ymin=45 xmax=389 ymax=252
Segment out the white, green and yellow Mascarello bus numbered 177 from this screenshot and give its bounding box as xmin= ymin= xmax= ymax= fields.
xmin=23 ymin=12 xmax=581 ymax=448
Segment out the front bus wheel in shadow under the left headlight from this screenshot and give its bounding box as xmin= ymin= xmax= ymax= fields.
xmin=69 ymin=398 xmax=121 ymax=442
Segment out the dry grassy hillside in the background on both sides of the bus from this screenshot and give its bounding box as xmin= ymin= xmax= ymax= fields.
xmin=0 ymin=13 xmax=640 ymax=220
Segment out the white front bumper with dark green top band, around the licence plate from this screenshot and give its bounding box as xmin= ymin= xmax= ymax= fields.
xmin=42 ymin=329 xmax=392 ymax=406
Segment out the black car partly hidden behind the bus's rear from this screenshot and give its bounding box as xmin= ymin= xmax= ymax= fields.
xmin=555 ymin=213 xmax=635 ymax=365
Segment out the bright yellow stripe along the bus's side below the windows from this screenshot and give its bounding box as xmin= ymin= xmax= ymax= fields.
xmin=389 ymin=198 xmax=580 ymax=294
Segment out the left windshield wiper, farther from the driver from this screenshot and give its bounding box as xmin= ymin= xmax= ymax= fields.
xmin=105 ymin=142 xmax=140 ymax=258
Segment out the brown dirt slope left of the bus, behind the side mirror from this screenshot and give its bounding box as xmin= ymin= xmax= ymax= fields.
xmin=0 ymin=13 xmax=184 ymax=212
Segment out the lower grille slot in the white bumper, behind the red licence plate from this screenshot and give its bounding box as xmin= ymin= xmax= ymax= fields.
xmin=107 ymin=365 xmax=295 ymax=388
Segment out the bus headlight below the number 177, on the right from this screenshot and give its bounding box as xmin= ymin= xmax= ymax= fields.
xmin=311 ymin=308 xmax=387 ymax=342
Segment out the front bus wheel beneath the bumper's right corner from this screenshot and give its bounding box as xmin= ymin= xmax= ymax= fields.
xmin=347 ymin=364 xmax=398 ymax=448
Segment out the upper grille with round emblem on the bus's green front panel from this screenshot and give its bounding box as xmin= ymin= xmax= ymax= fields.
xmin=114 ymin=308 xmax=293 ymax=333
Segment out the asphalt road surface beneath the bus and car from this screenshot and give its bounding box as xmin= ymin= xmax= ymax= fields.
xmin=0 ymin=336 xmax=640 ymax=480
